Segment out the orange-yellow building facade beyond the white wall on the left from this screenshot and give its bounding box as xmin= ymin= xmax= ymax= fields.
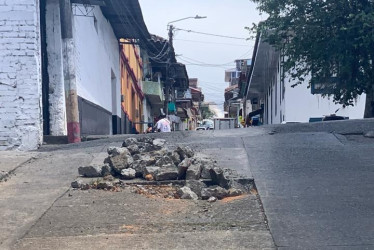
xmin=121 ymin=40 xmax=144 ymax=134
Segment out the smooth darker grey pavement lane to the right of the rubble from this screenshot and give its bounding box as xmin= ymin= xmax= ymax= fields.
xmin=177 ymin=119 xmax=374 ymax=249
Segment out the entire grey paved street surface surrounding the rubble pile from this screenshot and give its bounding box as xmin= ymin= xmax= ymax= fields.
xmin=0 ymin=119 xmax=374 ymax=250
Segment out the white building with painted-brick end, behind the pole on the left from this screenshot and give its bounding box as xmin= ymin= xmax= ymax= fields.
xmin=0 ymin=0 xmax=149 ymax=150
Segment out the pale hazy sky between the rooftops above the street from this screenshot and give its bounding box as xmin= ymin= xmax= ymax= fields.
xmin=139 ymin=0 xmax=264 ymax=117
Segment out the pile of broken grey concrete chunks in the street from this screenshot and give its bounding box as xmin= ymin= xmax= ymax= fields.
xmin=72 ymin=137 xmax=252 ymax=201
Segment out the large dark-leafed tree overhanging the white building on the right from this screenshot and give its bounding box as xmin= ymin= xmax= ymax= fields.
xmin=252 ymin=0 xmax=374 ymax=118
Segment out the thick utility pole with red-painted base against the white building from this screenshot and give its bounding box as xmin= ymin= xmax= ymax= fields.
xmin=59 ymin=0 xmax=81 ymax=143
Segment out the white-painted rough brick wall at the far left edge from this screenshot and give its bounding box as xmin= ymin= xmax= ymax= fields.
xmin=0 ymin=0 xmax=43 ymax=150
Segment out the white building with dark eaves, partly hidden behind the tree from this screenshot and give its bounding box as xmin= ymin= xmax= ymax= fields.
xmin=246 ymin=37 xmax=365 ymax=124
